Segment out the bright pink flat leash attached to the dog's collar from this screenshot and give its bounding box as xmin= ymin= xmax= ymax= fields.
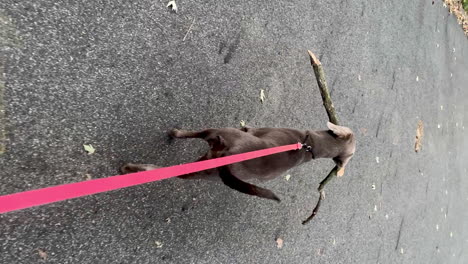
xmin=0 ymin=143 xmax=302 ymax=213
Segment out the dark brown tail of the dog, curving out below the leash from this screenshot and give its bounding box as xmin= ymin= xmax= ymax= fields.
xmin=219 ymin=166 xmax=281 ymax=202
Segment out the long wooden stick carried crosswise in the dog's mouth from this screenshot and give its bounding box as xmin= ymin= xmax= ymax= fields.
xmin=302 ymin=50 xmax=339 ymax=225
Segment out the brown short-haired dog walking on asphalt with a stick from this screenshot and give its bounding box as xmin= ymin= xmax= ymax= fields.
xmin=121 ymin=122 xmax=356 ymax=202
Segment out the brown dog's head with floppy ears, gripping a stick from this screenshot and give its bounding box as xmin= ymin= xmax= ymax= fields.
xmin=327 ymin=122 xmax=356 ymax=173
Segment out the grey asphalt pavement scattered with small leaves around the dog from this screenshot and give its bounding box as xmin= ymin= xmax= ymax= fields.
xmin=0 ymin=0 xmax=468 ymax=263
